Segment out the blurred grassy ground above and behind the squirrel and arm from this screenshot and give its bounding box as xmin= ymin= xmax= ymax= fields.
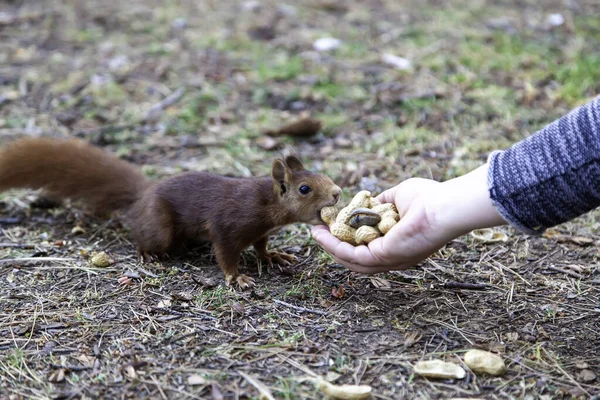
xmin=0 ymin=0 xmax=600 ymax=195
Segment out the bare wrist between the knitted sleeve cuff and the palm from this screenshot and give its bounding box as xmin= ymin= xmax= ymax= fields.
xmin=434 ymin=163 xmax=506 ymax=237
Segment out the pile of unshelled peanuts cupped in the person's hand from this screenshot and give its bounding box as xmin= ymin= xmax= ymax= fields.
xmin=321 ymin=190 xmax=400 ymax=246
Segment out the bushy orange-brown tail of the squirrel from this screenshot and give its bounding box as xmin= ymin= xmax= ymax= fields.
xmin=0 ymin=138 xmax=149 ymax=214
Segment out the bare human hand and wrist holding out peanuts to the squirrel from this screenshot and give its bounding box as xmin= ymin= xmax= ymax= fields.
xmin=312 ymin=164 xmax=505 ymax=274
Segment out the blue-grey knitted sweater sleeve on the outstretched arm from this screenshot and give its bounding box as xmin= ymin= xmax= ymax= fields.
xmin=488 ymin=97 xmax=600 ymax=234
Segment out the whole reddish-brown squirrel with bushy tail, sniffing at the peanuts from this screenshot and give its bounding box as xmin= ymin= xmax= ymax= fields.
xmin=0 ymin=138 xmax=342 ymax=288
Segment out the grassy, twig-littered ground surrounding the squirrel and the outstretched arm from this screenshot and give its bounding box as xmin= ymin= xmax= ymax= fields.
xmin=0 ymin=0 xmax=600 ymax=399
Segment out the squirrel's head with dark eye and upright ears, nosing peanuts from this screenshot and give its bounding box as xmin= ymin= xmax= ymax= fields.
xmin=271 ymin=154 xmax=342 ymax=225
